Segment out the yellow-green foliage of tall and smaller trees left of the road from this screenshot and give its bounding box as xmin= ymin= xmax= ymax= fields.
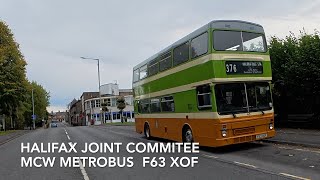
xmin=0 ymin=21 xmax=49 ymax=129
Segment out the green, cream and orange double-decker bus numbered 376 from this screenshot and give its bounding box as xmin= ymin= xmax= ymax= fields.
xmin=132 ymin=20 xmax=275 ymax=147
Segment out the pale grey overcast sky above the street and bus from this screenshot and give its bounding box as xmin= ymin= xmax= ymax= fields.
xmin=0 ymin=0 xmax=320 ymax=112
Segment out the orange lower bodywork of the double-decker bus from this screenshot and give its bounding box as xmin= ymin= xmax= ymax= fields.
xmin=136 ymin=114 xmax=275 ymax=147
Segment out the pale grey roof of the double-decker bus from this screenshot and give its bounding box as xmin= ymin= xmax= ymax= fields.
xmin=133 ymin=20 xmax=264 ymax=70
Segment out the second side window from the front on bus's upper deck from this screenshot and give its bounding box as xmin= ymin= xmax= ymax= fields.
xmin=173 ymin=42 xmax=189 ymax=66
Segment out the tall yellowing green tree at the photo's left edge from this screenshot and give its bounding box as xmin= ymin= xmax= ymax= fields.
xmin=0 ymin=21 xmax=28 ymax=128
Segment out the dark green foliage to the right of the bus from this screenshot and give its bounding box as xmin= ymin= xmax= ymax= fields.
xmin=269 ymin=31 xmax=320 ymax=113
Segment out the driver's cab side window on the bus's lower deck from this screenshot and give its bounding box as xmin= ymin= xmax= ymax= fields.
xmin=196 ymin=84 xmax=212 ymax=109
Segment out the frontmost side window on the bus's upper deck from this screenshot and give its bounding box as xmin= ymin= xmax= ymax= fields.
xmin=191 ymin=33 xmax=208 ymax=58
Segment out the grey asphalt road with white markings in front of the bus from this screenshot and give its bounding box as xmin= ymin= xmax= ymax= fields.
xmin=0 ymin=123 xmax=320 ymax=180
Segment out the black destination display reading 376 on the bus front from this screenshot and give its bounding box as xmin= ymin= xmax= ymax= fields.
xmin=226 ymin=61 xmax=263 ymax=74
